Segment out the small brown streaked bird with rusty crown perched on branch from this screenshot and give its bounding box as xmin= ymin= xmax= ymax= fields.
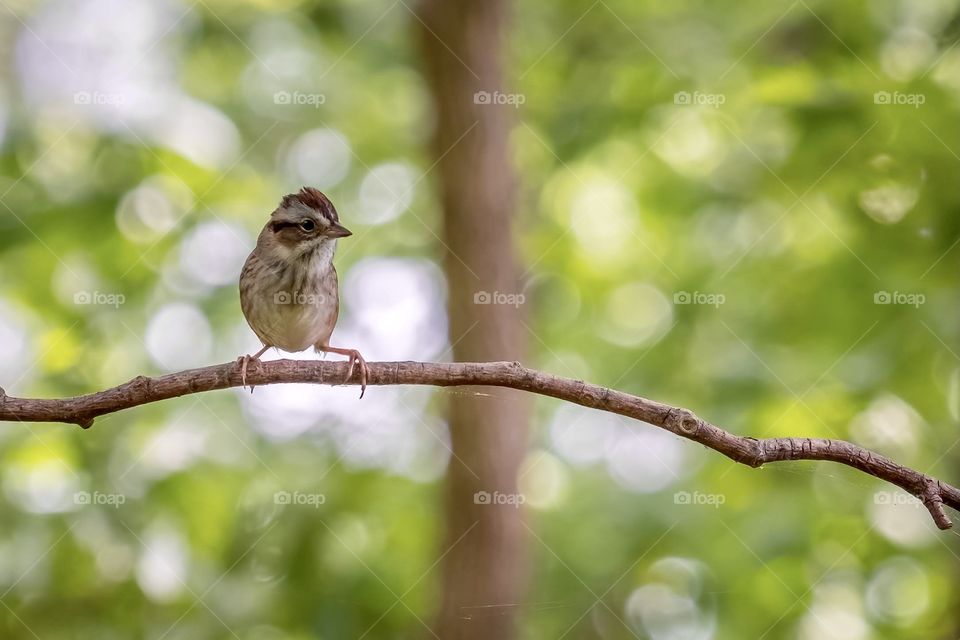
xmin=237 ymin=187 xmax=367 ymax=398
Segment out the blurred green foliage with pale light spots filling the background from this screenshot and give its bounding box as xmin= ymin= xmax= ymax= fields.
xmin=0 ymin=0 xmax=960 ymax=640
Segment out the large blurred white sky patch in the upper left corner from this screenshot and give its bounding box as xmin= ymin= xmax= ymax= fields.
xmin=16 ymin=0 xmax=240 ymax=169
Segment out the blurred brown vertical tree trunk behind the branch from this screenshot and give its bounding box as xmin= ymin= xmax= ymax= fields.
xmin=418 ymin=0 xmax=528 ymax=640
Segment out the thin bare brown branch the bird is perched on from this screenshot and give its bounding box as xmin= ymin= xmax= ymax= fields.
xmin=0 ymin=360 xmax=960 ymax=529
